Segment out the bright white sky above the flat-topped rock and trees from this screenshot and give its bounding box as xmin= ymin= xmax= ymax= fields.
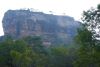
xmin=0 ymin=0 xmax=100 ymax=36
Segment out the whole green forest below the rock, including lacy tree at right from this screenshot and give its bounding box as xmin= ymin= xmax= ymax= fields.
xmin=0 ymin=5 xmax=100 ymax=67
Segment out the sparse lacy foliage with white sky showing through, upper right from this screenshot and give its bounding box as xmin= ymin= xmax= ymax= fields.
xmin=82 ymin=4 xmax=100 ymax=38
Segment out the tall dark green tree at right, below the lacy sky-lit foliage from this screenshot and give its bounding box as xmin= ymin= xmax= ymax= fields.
xmin=74 ymin=28 xmax=99 ymax=67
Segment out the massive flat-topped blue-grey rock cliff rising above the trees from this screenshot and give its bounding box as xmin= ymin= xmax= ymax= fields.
xmin=2 ymin=10 xmax=79 ymax=44
